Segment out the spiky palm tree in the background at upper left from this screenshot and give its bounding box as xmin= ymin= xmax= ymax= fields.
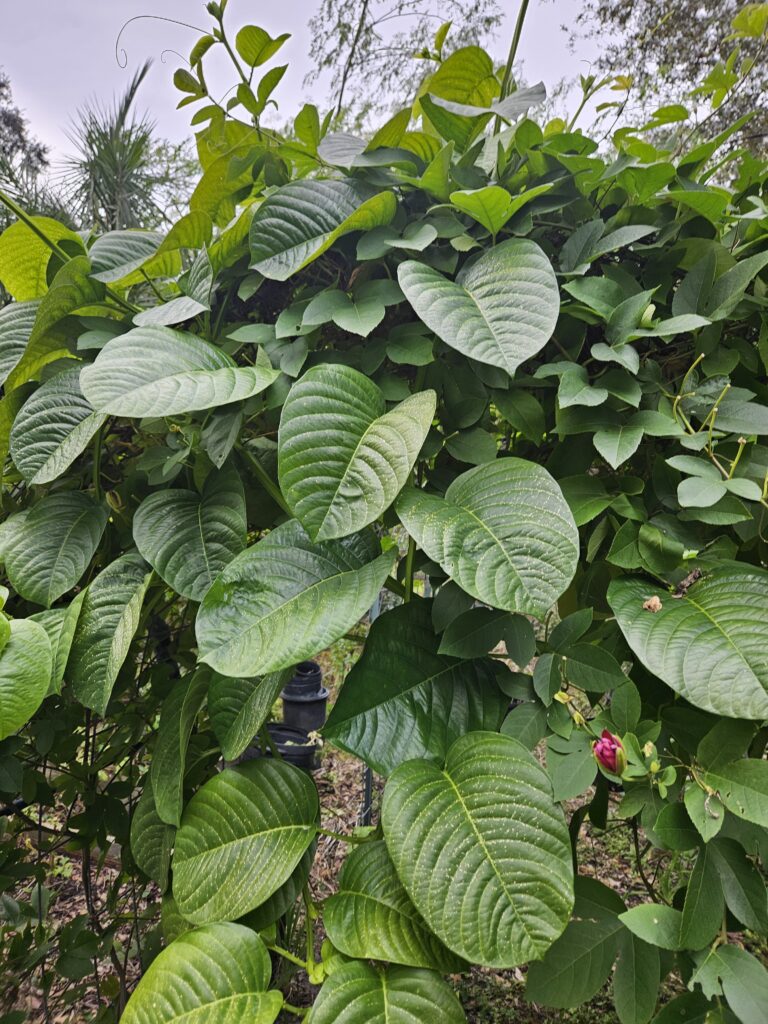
xmin=62 ymin=60 xmax=163 ymax=231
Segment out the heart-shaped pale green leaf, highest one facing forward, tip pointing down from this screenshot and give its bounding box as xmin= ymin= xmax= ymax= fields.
xmin=397 ymin=239 xmax=560 ymax=376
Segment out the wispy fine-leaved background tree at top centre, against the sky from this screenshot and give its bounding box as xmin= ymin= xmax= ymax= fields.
xmin=304 ymin=0 xmax=502 ymax=127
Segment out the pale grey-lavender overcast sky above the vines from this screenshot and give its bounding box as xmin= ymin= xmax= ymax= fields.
xmin=0 ymin=0 xmax=594 ymax=161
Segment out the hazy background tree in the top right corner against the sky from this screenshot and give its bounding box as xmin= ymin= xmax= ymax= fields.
xmin=563 ymin=0 xmax=768 ymax=153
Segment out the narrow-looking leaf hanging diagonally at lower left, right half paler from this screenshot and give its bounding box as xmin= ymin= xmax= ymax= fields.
xmin=67 ymin=554 xmax=152 ymax=715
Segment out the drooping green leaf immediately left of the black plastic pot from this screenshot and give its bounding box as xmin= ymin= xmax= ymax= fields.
xmin=208 ymin=669 xmax=292 ymax=761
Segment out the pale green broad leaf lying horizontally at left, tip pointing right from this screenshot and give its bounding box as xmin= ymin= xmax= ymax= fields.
xmin=80 ymin=327 xmax=280 ymax=417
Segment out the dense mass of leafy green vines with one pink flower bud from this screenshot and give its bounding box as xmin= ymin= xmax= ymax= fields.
xmin=0 ymin=4 xmax=768 ymax=1024
